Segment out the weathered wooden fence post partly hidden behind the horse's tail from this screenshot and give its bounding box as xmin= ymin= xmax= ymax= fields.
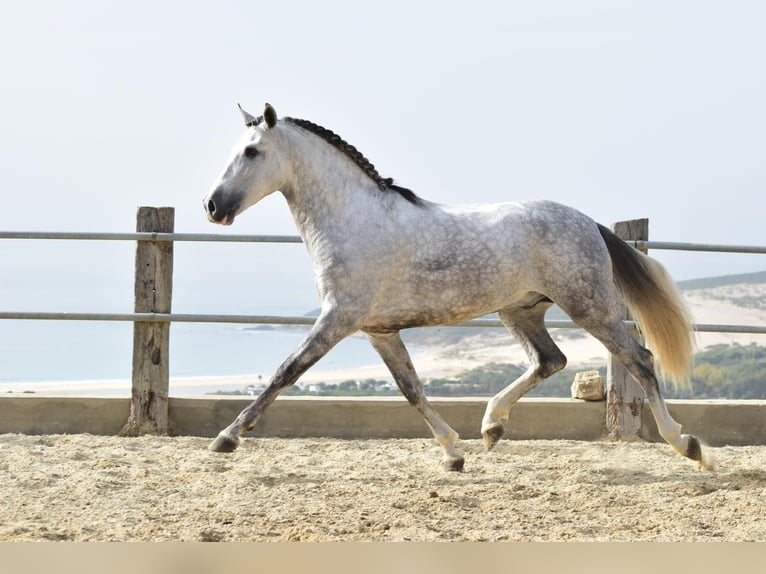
xmin=606 ymin=219 xmax=649 ymax=440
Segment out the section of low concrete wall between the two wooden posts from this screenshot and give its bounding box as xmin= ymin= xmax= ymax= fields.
xmin=165 ymin=397 xmax=604 ymax=440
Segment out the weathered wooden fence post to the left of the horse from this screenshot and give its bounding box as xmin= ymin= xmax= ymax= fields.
xmin=120 ymin=207 xmax=175 ymax=436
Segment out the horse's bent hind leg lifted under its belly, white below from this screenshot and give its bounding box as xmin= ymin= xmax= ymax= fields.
xmin=481 ymin=301 xmax=567 ymax=450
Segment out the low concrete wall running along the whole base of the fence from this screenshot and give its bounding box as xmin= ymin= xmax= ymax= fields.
xmin=0 ymin=395 xmax=766 ymax=446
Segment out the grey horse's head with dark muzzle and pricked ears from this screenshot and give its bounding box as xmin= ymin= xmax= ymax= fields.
xmin=204 ymin=104 xmax=284 ymax=225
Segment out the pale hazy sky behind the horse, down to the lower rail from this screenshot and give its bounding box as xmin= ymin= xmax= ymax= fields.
xmin=0 ymin=0 xmax=766 ymax=318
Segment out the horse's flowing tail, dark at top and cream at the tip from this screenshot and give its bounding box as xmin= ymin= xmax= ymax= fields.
xmin=599 ymin=225 xmax=695 ymax=387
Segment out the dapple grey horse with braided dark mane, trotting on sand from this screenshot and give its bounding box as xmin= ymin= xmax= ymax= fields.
xmin=204 ymin=104 xmax=710 ymax=470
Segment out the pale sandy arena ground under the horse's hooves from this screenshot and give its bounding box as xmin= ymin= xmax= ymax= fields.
xmin=0 ymin=434 xmax=766 ymax=542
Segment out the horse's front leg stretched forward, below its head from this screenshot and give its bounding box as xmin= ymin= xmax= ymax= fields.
xmin=208 ymin=314 xmax=356 ymax=452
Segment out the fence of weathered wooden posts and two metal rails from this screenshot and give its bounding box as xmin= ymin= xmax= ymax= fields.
xmin=0 ymin=207 xmax=766 ymax=436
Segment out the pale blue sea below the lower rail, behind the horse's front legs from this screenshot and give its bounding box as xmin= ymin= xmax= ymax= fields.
xmin=0 ymin=316 xmax=390 ymax=395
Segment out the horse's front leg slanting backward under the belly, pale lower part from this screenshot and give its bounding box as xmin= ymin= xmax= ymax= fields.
xmin=367 ymin=333 xmax=464 ymax=470
